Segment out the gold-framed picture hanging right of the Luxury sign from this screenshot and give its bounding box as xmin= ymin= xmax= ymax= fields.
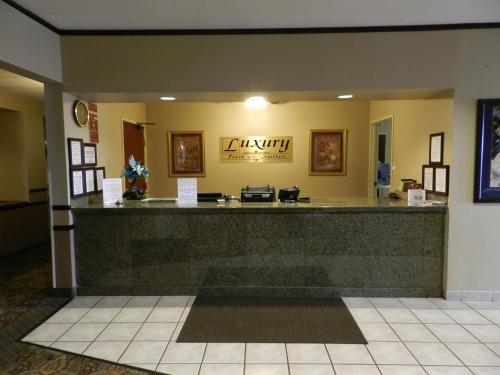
xmin=309 ymin=129 xmax=347 ymax=176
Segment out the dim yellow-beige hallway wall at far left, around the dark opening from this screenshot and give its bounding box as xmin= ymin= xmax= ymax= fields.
xmin=0 ymin=93 xmax=47 ymax=194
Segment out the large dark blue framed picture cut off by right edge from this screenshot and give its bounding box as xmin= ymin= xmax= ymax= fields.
xmin=474 ymin=99 xmax=500 ymax=203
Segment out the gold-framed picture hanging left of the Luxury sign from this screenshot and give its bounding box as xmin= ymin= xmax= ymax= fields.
xmin=167 ymin=131 xmax=205 ymax=177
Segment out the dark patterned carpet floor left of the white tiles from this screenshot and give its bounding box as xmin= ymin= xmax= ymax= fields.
xmin=0 ymin=243 xmax=149 ymax=375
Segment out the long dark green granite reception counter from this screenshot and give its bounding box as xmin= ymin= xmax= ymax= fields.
xmin=72 ymin=200 xmax=447 ymax=297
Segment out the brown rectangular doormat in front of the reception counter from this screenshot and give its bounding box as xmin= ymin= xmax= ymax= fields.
xmin=177 ymin=296 xmax=367 ymax=344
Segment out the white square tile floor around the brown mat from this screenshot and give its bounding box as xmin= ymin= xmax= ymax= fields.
xmin=23 ymin=296 xmax=500 ymax=375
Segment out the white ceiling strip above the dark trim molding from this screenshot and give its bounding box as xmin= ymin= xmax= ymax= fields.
xmin=8 ymin=0 xmax=500 ymax=30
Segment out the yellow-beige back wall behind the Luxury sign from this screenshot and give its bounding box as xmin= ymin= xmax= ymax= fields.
xmin=147 ymin=102 xmax=369 ymax=197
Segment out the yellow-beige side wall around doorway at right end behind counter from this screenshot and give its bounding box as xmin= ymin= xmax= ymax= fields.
xmin=370 ymin=99 xmax=453 ymax=190
